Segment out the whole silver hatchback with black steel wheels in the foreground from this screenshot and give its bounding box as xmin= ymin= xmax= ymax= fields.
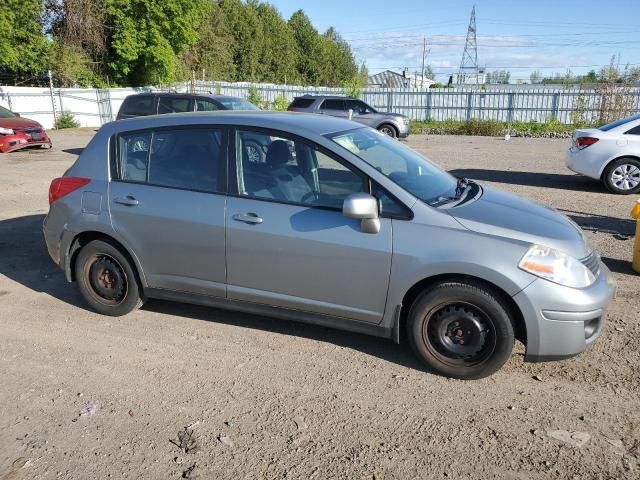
xmin=44 ymin=112 xmax=615 ymax=379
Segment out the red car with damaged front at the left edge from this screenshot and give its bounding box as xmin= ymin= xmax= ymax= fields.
xmin=0 ymin=107 xmax=51 ymax=153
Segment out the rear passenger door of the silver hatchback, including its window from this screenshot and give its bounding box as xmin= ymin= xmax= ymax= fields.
xmin=109 ymin=125 xmax=228 ymax=297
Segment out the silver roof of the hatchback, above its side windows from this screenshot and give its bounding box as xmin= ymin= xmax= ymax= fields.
xmin=101 ymin=110 xmax=364 ymax=136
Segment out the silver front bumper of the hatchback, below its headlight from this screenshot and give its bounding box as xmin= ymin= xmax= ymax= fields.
xmin=513 ymin=262 xmax=616 ymax=362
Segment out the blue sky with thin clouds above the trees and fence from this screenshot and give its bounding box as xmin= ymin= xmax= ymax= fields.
xmin=268 ymin=0 xmax=640 ymax=82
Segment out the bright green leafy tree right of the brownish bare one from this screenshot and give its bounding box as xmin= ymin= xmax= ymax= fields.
xmin=106 ymin=0 xmax=208 ymax=85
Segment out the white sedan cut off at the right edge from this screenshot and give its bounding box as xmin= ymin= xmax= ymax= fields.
xmin=566 ymin=114 xmax=640 ymax=195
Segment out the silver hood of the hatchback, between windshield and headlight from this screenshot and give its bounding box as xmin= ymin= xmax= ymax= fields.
xmin=447 ymin=186 xmax=589 ymax=259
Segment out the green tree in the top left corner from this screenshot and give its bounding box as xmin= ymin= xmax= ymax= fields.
xmin=0 ymin=0 xmax=51 ymax=79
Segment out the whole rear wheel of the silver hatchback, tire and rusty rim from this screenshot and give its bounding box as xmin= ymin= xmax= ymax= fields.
xmin=74 ymin=240 xmax=143 ymax=317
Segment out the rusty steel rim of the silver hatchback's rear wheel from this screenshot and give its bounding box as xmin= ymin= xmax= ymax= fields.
xmin=83 ymin=253 xmax=129 ymax=306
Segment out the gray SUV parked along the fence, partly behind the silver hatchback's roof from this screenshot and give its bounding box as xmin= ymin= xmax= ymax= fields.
xmin=288 ymin=95 xmax=409 ymax=138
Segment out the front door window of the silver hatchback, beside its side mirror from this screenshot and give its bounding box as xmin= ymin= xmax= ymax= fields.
xmin=236 ymin=130 xmax=366 ymax=209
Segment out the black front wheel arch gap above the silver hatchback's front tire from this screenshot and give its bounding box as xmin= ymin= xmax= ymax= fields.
xmin=397 ymin=273 xmax=527 ymax=346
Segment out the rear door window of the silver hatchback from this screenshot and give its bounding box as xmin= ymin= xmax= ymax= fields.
xmin=118 ymin=127 xmax=226 ymax=193
